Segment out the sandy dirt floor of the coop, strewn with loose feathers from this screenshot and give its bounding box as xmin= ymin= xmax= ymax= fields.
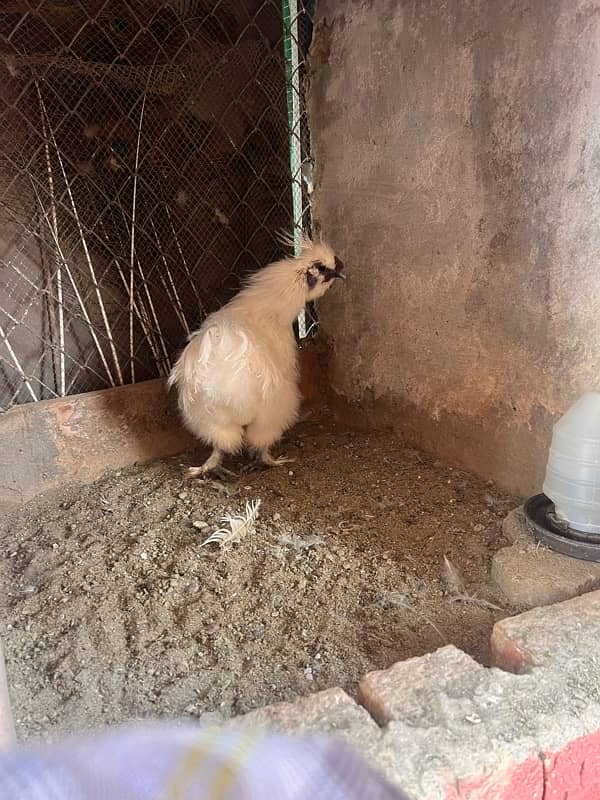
xmin=0 ymin=422 xmax=517 ymax=738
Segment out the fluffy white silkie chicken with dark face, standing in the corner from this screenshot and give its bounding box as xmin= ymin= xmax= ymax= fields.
xmin=169 ymin=238 xmax=344 ymax=476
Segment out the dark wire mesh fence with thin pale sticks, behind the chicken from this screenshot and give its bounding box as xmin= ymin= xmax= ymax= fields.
xmin=0 ymin=0 xmax=313 ymax=410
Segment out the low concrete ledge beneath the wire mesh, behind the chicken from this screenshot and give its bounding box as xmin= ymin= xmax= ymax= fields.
xmin=0 ymin=346 xmax=322 ymax=510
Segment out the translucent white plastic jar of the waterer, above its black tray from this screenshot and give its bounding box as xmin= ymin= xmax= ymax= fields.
xmin=543 ymin=392 xmax=600 ymax=537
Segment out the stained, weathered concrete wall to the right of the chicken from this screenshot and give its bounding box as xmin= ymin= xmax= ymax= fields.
xmin=310 ymin=0 xmax=600 ymax=492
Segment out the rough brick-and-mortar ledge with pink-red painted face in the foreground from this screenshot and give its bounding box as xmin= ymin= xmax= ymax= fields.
xmin=223 ymin=592 xmax=600 ymax=800
